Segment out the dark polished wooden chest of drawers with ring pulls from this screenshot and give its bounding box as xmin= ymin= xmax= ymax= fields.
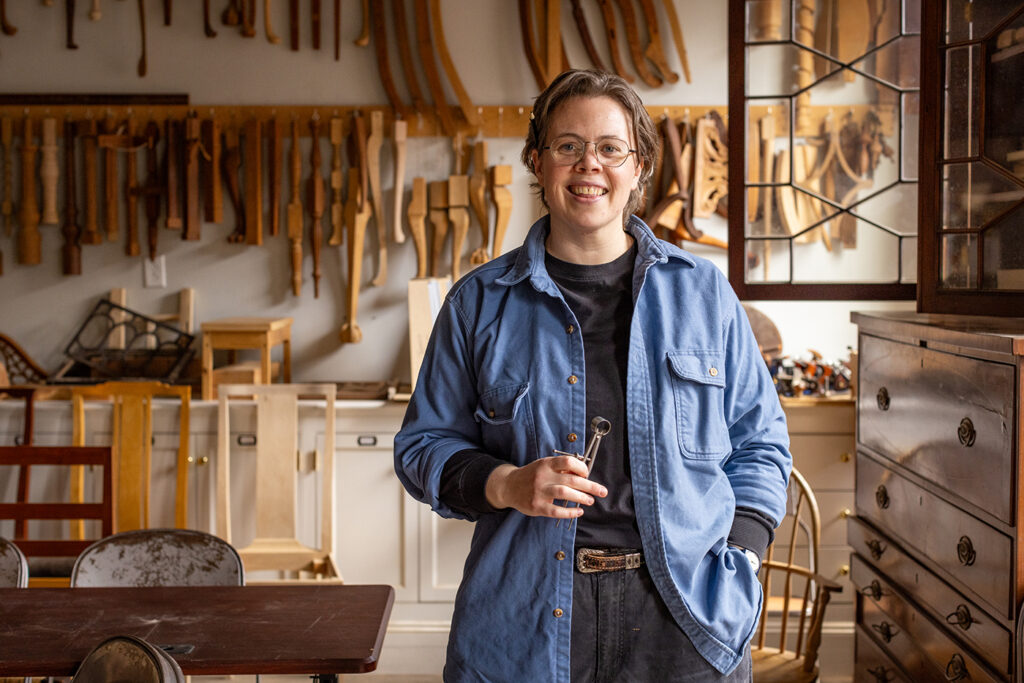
xmin=848 ymin=313 xmax=1024 ymax=683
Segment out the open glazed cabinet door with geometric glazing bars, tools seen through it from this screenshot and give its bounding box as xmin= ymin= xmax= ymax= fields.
xmin=729 ymin=0 xmax=921 ymax=299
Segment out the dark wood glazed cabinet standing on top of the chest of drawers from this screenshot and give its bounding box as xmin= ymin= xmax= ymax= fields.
xmin=919 ymin=0 xmax=1024 ymax=316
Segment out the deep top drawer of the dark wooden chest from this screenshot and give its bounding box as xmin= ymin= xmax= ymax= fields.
xmin=857 ymin=335 xmax=1016 ymax=523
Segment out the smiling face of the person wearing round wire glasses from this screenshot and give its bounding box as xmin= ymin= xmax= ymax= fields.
xmin=534 ymin=96 xmax=641 ymax=237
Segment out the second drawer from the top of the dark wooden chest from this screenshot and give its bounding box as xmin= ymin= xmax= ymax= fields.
xmin=857 ymin=453 xmax=1014 ymax=620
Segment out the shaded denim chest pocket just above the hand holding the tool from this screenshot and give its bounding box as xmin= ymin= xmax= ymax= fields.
xmin=473 ymin=382 xmax=537 ymax=465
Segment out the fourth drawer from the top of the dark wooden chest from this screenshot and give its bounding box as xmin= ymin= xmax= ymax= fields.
xmin=853 ymin=563 xmax=1001 ymax=683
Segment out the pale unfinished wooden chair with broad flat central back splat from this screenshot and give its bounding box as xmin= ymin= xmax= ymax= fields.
xmin=217 ymin=384 xmax=341 ymax=581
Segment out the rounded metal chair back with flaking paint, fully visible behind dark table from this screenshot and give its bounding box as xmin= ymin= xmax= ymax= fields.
xmin=71 ymin=528 xmax=246 ymax=588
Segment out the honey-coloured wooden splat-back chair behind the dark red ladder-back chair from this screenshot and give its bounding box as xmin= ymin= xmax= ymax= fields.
xmin=71 ymin=382 xmax=191 ymax=539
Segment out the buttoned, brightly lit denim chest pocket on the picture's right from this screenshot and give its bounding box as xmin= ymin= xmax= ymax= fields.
xmin=668 ymin=350 xmax=732 ymax=460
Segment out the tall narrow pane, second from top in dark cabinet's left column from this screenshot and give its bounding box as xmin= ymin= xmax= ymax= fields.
xmin=943 ymin=45 xmax=981 ymax=159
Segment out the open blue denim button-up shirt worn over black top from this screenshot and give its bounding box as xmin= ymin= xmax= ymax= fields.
xmin=395 ymin=217 xmax=792 ymax=683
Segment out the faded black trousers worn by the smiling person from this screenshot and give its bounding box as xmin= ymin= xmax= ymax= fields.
xmin=571 ymin=566 xmax=754 ymax=683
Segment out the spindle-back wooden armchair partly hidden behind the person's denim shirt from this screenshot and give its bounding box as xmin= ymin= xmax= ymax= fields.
xmin=751 ymin=469 xmax=842 ymax=683
